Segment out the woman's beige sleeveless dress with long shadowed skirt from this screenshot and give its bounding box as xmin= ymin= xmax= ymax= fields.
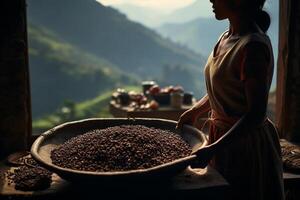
xmin=205 ymin=30 xmax=284 ymax=200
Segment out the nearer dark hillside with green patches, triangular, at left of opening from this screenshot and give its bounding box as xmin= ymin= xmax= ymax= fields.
xmin=28 ymin=24 xmax=140 ymax=118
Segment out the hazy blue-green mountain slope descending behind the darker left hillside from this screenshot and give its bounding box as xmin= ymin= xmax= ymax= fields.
xmin=28 ymin=0 xmax=204 ymax=77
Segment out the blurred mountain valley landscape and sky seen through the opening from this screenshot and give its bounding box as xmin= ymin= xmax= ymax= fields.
xmin=27 ymin=0 xmax=279 ymax=134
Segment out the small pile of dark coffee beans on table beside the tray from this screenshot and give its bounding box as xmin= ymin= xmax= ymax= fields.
xmin=7 ymin=157 xmax=52 ymax=191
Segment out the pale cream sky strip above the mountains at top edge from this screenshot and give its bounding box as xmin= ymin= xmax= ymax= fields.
xmin=97 ymin=0 xmax=195 ymax=12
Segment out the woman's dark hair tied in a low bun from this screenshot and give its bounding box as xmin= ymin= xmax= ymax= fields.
xmin=241 ymin=0 xmax=271 ymax=32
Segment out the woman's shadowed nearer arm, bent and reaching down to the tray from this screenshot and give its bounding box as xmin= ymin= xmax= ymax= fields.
xmin=196 ymin=42 xmax=270 ymax=166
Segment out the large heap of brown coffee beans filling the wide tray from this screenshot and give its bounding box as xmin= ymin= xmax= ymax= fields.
xmin=51 ymin=125 xmax=192 ymax=172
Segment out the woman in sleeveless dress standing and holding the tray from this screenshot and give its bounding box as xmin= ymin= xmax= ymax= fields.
xmin=177 ymin=0 xmax=284 ymax=200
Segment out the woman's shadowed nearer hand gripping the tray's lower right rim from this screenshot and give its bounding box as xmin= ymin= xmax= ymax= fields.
xmin=191 ymin=145 xmax=215 ymax=168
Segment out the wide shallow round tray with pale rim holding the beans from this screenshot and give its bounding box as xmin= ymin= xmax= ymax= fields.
xmin=31 ymin=118 xmax=207 ymax=181
